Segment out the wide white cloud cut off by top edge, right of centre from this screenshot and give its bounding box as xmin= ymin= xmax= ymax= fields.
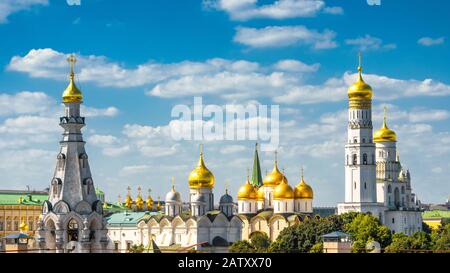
xmin=203 ymin=0 xmax=343 ymax=21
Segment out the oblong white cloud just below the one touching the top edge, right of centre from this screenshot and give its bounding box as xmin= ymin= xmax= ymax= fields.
xmin=233 ymin=26 xmax=337 ymax=49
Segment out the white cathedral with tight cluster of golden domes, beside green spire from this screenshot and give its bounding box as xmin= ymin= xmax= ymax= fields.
xmin=237 ymin=146 xmax=314 ymax=240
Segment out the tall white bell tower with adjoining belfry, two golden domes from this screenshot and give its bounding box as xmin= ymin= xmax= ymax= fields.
xmin=338 ymin=55 xmax=422 ymax=235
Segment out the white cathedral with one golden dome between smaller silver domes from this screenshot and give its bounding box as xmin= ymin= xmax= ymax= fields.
xmin=126 ymin=145 xmax=242 ymax=252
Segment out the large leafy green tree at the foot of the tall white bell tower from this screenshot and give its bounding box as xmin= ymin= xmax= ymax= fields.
xmin=344 ymin=213 xmax=391 ymax=252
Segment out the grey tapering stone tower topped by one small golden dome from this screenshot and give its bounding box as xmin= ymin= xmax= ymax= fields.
xmin=37 ymin=55 xmax=108 ymax=253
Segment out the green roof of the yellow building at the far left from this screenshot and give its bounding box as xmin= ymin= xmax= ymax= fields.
xmin=0 ymin=191 xmax=48 ymax=206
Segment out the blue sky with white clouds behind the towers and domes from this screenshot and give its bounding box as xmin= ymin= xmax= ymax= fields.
xmin=0 ymin=0 xmax=450 ymax=206
